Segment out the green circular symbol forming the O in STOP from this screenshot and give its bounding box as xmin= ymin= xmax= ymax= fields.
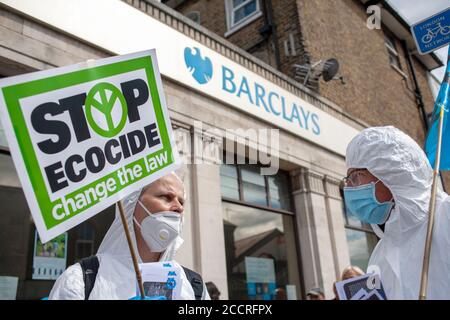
xmin=86 ymin=82 xmax=128 ymax=138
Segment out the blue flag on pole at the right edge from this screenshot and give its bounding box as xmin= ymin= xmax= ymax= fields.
xmin=425 ymin=46 xmax=450 ymax=170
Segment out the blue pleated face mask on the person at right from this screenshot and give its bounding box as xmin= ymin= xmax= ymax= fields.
xmin=344 ymin=180 xmax=394 ymax=224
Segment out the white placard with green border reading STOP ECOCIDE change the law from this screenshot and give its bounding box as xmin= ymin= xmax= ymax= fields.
xmin=0 ymin=50 xmax=180 ymax=242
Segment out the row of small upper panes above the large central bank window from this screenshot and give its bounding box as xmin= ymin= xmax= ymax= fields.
xmin=220 ymin=164 xmax=291 ymax=211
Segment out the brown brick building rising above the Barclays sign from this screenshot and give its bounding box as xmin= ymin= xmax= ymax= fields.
xmin=170 ymin=0 xmax=450 ymax=186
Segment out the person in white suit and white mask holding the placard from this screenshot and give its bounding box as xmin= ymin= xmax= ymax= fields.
xmin=49 ymin=173 xmax=210 ymax=300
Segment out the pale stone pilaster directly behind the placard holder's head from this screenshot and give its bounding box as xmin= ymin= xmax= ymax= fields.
xmin=191 ymin=128 xmax=228 ymax=299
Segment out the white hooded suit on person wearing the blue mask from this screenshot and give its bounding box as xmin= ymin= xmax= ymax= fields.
xmin=346 ymin=126 xmax=450 ymax=299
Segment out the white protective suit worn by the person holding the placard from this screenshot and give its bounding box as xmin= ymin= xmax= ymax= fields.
xmin=49 ymin=191 xmax=210 ymax=300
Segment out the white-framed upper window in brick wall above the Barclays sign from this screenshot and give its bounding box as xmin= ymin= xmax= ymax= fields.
xmin=225 ymin=0 xmax=260 ymax=29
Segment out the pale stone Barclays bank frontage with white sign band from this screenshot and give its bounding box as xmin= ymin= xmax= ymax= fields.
xmin=0 ymin=0 xmax=370 ymax=299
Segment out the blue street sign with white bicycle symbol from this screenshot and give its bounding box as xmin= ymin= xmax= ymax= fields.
xmin=411 ymin=8 xmax=450 ymax=54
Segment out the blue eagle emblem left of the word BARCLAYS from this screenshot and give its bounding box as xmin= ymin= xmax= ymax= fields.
xmin=184 ymin=47 xmax=213 ymax=84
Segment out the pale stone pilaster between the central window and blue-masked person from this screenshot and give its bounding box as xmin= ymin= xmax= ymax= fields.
xmin=291 ymin=168 xmax=348 ymax=299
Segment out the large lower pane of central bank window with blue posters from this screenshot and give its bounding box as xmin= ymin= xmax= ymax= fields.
xmin=222 ymin=202 xmax=301 ymax=300
